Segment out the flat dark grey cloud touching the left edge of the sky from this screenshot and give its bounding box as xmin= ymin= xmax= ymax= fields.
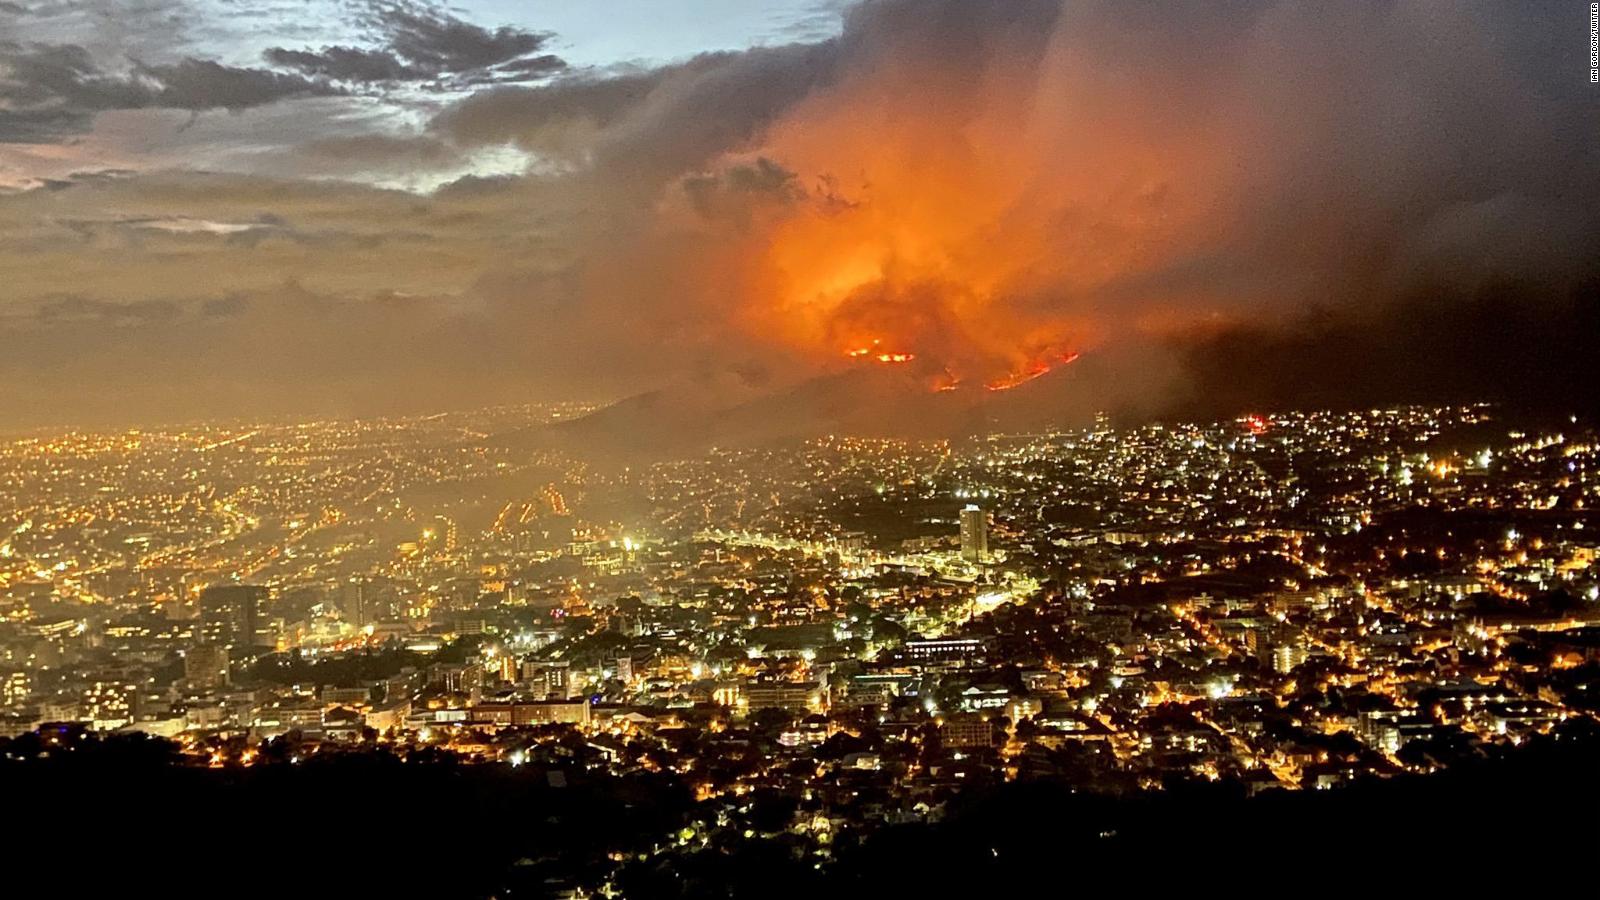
xmin=0 ymin=42 xmax=338 ymax=143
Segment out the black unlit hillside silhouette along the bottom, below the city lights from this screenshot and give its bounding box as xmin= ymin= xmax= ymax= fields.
xmin=0 ymin=721 xmax=1600 ymax=898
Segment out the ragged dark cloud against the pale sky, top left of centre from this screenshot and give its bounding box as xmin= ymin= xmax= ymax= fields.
xmin=264 ymin=2 xmax=566 ymax=86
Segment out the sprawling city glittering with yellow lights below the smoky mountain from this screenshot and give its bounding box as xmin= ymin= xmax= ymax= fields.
xmin=0 ymin=404 xmax=1600 ymax=895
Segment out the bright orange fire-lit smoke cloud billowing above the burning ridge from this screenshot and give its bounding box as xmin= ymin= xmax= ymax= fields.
xmin=668 ymin=4 xmax=1232 ymax=389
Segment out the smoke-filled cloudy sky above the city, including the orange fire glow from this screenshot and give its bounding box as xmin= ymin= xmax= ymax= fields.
xmin=0 ymin=0 xmax=1600 ymax=428
